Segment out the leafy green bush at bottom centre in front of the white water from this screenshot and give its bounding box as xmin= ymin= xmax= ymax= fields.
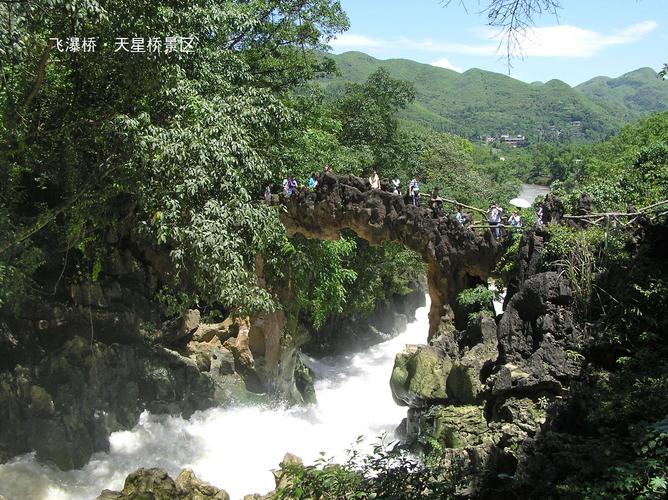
xmin=272 ymin=436 xmax=469 ymax=500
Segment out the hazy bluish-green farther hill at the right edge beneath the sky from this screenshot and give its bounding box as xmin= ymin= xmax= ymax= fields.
xmin=575 ymin=68 xmax=668 ymax=117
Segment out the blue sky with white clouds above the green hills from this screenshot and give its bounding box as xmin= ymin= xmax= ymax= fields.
xmin=330 ymin=0 xmax=668 ymax=85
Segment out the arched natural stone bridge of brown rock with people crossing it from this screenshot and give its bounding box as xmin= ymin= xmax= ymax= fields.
xmin=274 ymin=172 xmax=502 ymax=339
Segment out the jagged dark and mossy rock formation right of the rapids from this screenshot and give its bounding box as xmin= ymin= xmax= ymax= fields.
xmin=390 ymin=226 xmax=586 ymax=496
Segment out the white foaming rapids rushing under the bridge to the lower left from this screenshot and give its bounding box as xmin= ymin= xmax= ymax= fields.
xmin=0 ymin=298 xmax=429 ymax=500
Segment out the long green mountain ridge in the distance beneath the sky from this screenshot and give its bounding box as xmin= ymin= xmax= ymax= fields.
xmin=320 ymin=52 xmax=668 ymax=141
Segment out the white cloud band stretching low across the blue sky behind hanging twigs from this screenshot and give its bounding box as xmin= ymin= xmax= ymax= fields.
xmin=331 ymin=21 xmax=658 ymax=59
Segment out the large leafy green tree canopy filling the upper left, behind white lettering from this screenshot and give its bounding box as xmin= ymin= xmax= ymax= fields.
xmin=0 ymin=0 xmax=348 ymax=311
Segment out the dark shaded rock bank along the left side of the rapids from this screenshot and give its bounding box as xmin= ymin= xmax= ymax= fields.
xmin=0 ymin=337 xmax=227 ymax=469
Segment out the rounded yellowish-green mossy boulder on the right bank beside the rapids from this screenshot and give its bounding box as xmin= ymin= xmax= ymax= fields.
xmin=390 ymin=345 xmax=452 ymax=408
